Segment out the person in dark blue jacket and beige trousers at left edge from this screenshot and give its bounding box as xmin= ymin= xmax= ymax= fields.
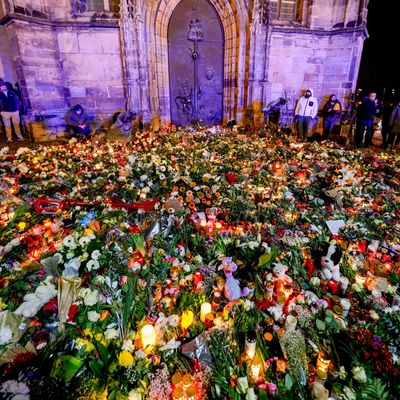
xmin=0 ymin=81 xmax=24 ymax=143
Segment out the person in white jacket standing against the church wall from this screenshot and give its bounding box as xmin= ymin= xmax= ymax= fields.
xmin=294 ymin=89 xmax=318 ymax=141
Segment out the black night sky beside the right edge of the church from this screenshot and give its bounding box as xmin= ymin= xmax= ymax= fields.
xmin=357 ymin=0 xmax=400 ymax=99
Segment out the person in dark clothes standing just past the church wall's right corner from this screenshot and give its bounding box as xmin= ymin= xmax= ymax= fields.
xmin=354 ymin=92 xmax=379 ymax=147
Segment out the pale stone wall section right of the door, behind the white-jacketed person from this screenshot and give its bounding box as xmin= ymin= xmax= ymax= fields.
xmin=268 ymin=31 xmax=360 ymax=108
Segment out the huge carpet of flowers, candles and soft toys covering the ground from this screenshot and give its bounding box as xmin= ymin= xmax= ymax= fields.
xmin=0 ymin=127 xmax=400 ymax=400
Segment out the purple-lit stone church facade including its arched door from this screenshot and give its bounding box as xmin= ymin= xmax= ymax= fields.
xmin=0 ymin=0 xmax=368 ymax=128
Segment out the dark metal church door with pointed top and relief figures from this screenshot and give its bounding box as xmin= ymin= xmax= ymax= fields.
xmin=168 ymin=0 xmax=224 ymax=126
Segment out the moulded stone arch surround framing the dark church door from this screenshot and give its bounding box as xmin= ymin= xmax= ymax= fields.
xmin=143 ymin=0 xmax=249 ymax=121
